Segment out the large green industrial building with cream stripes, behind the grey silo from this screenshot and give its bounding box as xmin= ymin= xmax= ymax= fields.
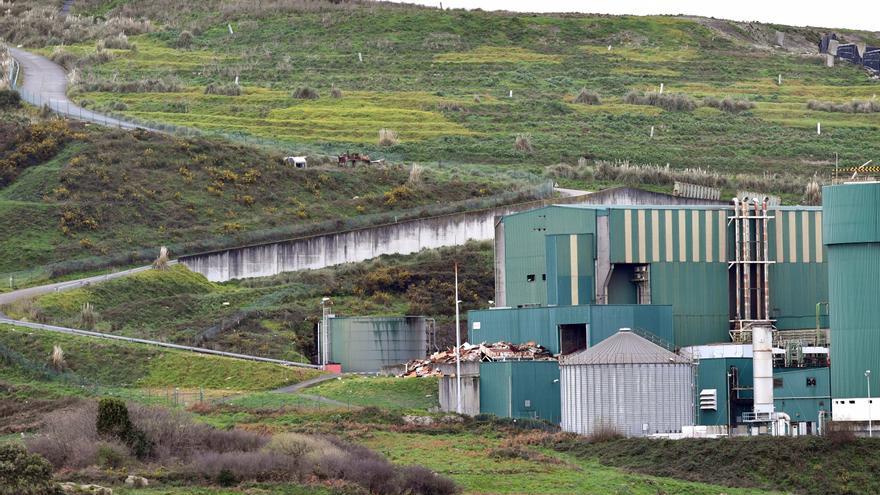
xmin=468 ymin=196 xmax=836 ymax=433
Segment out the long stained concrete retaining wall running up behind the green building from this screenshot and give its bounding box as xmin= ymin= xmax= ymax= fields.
xmin=178 ymin=187 xmax=728 ymax=282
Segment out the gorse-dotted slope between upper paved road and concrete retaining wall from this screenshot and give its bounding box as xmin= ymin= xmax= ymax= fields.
xmin=0 ymin=109 xmax=528 ymax=284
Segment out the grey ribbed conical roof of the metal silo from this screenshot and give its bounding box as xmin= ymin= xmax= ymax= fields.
xmin=560 ymin=330 xmax=691 ymax=366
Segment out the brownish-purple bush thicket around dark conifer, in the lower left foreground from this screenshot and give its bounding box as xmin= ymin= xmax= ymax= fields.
xmin=24 ymin=399 xmax=458 ymax=495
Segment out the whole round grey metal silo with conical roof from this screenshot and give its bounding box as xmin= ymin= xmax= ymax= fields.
xmin=559 ymin=329 xmax=694 ymax=436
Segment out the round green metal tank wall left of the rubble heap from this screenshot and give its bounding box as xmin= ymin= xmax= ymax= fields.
xmin=329 ymin=316 xmax=427 ymax=372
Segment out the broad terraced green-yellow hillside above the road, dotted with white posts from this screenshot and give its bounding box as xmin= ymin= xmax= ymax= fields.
xmin=13 ymin=0 xmax=880 ymax=175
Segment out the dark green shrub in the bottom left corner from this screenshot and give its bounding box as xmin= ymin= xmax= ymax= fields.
xmin=0 ymin=444 xmax=62 ymax=495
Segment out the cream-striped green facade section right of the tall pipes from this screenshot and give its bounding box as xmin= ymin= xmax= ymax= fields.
xmin=767 ymin=208 xmax=826 ymax=263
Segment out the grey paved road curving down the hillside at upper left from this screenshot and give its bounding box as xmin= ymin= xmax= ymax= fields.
xmin=9 ymin=48 xmax=156 ymax=131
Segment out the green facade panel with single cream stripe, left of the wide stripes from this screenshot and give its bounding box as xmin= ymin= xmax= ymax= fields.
xmin=546 ymin=234 xmax=596 ymax=306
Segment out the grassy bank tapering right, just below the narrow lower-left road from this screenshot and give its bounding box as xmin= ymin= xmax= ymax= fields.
xmin=0 ymin=325 xmax=318 ymax=390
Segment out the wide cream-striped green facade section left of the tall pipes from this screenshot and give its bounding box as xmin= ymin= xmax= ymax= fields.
xmin=610 ymin=209 xmax=728 ymax=263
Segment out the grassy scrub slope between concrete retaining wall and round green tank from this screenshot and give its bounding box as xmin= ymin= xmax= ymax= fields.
xmin=2 ymin=243 xmax=493 ymax=361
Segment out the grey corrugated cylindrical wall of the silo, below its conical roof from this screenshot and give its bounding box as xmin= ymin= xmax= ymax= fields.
xmin=560 ymin=364 xmax=694 ymax=436
